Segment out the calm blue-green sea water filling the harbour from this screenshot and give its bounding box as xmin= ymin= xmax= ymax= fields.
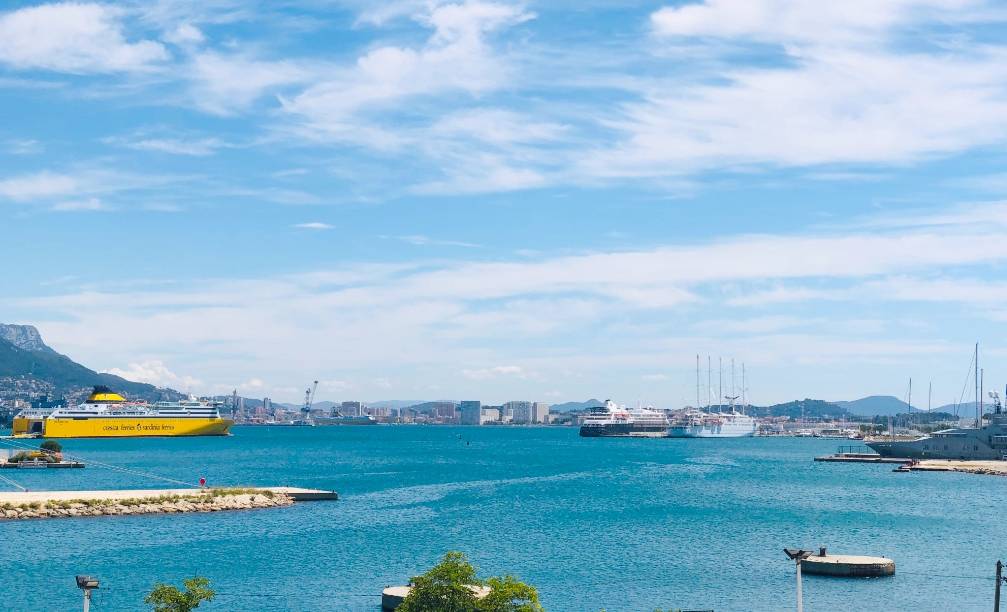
xmin=0 ymin=427 xmax=1007 ymax=612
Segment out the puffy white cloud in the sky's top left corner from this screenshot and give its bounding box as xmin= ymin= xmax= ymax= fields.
xmin=0 ymin=2 xmax=169 ymax=72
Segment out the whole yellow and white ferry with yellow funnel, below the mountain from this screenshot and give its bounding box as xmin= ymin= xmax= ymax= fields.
xmin=12 ymin=387 xmax=235 ymax=438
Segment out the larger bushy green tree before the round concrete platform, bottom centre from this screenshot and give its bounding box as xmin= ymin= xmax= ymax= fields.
xmin=397 ymin=551 xmax=543 ymax=612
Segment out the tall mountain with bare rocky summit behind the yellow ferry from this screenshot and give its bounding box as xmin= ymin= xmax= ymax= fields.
xmin=0 ymin=324 xmax=175 ymax=400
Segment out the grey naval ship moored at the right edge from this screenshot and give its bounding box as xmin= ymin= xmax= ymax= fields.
xmin=865 ymin=394 xmax=1007 ymax=460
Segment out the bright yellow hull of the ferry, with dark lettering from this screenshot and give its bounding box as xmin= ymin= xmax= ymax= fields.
xmin=12 ymin=417 xmax=235 ymax=438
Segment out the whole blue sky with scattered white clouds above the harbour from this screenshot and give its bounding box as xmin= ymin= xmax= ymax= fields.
xmin=0 ymin=0 xmax=1007 ymax=408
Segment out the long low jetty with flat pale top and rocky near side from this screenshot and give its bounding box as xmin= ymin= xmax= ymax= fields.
xmin=0 ymin=487 xmax=337 ymax=520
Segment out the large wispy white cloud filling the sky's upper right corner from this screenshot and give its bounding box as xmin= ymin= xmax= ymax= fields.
xmin=580 ymin=0 xmax=1007 ymax=177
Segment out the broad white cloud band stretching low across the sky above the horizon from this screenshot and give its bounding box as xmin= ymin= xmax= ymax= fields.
xmin=17 ymin=201 xmax=1007 ymax=400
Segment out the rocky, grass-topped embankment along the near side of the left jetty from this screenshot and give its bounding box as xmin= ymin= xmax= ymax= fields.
xmin=0 ymin=489 xmax=294 ymax=520
